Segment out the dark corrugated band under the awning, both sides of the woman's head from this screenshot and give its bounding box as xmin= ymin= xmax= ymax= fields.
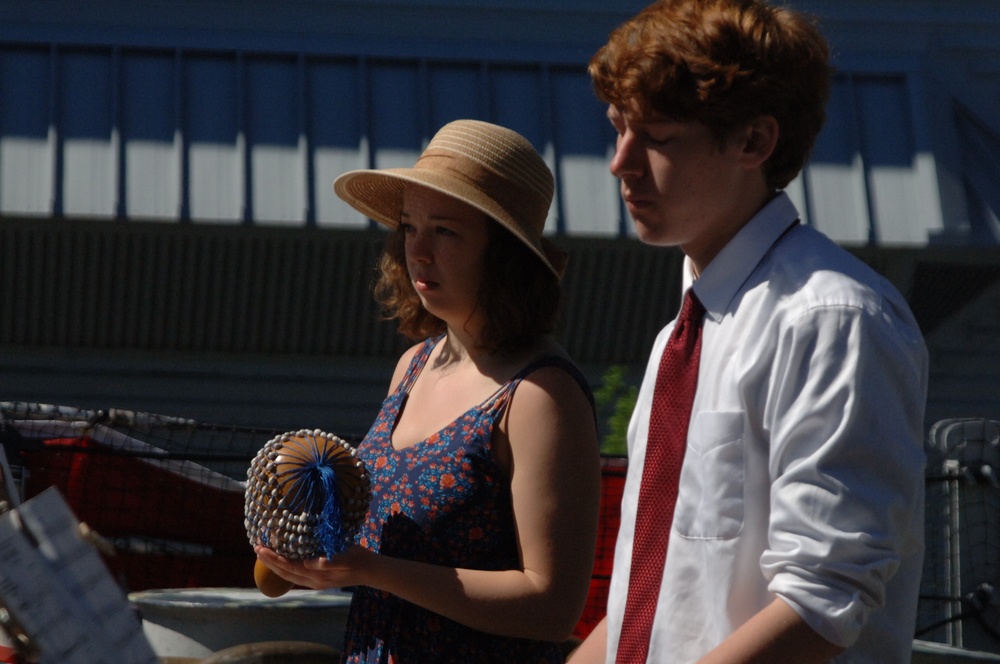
xmin=0 ymin=219 xmax=681 ymax=364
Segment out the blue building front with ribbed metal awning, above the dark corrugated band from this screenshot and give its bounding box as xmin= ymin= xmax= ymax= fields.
xmin=0 ymin=0 xmax=1000 ymax=245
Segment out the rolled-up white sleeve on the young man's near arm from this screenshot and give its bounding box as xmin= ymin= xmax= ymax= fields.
xmin=760 ymin=300 xmax=927 ymax=647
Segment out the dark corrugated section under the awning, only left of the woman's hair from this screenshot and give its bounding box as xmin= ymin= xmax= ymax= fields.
xmin=0 ymin=220 xmax=399 ymax=356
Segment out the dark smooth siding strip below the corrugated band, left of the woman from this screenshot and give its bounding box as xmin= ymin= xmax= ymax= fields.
xmin=0 ymin=349 xmax=394 ymax=434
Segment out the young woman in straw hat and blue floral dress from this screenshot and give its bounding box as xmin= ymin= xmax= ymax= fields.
xmin=257 ymin=120 xmax=600 ymax=663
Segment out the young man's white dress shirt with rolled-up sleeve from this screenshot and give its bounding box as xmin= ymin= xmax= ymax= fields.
xmin=608 ymin=194 xmax=927 ymax=664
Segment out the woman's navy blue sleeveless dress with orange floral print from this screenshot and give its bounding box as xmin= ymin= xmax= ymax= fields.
xmin=344 ymin=339 xmax=590 ymax=664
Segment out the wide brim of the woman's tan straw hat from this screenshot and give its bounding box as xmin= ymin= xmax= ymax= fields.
xmin=333 ymin=168 xmax=562 ymax=279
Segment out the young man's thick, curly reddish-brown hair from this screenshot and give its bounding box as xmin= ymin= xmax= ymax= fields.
xmin=588 ymin=0 xmax=830 ymax=189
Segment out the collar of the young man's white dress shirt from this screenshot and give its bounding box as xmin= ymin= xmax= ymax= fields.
xmin=683 ymin=192 xmax=799 ymax=321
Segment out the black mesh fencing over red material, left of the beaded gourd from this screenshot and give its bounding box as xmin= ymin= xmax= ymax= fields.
xmin=0 ymin=402 xmax=356 ymax=591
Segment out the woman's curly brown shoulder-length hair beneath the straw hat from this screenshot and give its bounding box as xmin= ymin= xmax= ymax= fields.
xmin=374 ymin=221 xmax=562 ymax=352
